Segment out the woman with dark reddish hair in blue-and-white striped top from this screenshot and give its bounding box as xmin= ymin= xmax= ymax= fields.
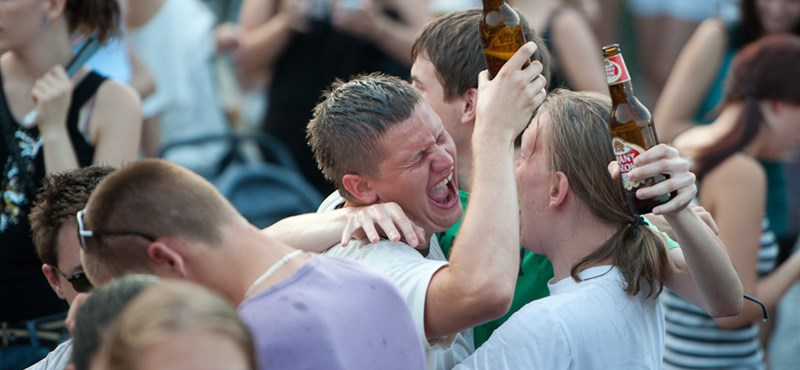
xmin=664 ymin=34 xmax=800 ymax=369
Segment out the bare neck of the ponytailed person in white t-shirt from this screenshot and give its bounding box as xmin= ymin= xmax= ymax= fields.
xmin=543 ymin=202 xmax=616 ymax=281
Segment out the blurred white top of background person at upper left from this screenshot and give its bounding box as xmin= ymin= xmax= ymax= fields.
xmin=127 ymin=0 xmax=228 ymax=175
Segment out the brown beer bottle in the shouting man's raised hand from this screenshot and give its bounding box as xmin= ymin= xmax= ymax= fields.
xmin=480 ymin=0 xmax=525 ymax=78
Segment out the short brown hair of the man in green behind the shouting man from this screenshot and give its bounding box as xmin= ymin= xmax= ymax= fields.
xmin=411 ymin=9 xmax=551 ymax=101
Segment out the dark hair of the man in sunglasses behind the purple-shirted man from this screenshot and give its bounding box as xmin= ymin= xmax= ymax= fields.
xmin=29 ymin=166 xmax=114 ymax=266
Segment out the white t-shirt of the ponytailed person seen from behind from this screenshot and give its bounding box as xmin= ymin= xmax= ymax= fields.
xmin=455 ymin=266 xmax=664 ymax=370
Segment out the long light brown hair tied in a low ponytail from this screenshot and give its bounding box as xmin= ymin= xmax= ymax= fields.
xmin=539 ymin=89 xmax=669 ymax=297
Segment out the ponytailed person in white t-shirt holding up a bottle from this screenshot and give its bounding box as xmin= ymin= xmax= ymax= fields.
xmin=457 ymin=90 xmax=741 ymax=369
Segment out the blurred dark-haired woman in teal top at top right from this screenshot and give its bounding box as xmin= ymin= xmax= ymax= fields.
xmin=653 ymin=0 xmax=800 ymax=263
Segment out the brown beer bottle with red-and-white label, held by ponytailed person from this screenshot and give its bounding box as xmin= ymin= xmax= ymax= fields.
xmin=603 ymin=44 xmax=671 ymax=215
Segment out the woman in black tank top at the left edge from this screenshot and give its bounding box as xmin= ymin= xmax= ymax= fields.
xmin=0 ymin=0 xmax=141 ymax=369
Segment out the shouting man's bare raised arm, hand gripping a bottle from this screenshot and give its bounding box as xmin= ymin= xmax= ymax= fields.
xmin=425 ymin=43 xmax=545 ymax=339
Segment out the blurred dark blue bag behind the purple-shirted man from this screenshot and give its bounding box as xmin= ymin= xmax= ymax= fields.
xmin=161 ymin=133 xmax=322 ymax=228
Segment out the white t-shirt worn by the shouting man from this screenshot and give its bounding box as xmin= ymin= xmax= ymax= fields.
xmin=317 ymin=192 xmax=475 ymax=370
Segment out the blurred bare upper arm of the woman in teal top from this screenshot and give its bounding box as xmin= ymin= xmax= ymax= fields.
xmin=653 ymin=19 xmax=728 ymax=143
